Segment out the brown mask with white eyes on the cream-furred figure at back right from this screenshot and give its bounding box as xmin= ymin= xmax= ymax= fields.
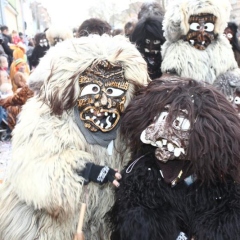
xmin=185 ymin=13 xmax=216 ymax=50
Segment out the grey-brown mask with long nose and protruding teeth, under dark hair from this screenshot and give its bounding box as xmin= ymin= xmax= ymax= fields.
xmin=140 ymin=106 xmax=191 ymax=162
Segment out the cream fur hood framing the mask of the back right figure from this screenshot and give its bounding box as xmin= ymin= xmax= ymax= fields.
xmin=163 ymin=0 xmax=231 ymax=42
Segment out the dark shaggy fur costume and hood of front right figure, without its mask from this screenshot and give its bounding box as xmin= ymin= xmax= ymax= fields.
xmin=108 ymin=80 xmax=240 ymax=240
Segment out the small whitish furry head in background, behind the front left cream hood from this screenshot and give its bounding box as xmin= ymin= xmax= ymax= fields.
xmin=46 ymin=26 xmax=73 ymax=47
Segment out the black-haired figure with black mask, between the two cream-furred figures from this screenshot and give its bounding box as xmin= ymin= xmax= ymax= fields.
xmin=130 ymin=16 xmax=165 ymax=79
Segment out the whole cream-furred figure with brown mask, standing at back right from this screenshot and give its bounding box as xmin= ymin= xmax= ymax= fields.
xmin=161 ymin=0 xmax=240 ymax=83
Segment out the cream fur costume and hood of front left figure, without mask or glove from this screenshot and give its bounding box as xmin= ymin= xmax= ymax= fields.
xmin=0 ymin=36 xmax=149 ymax=240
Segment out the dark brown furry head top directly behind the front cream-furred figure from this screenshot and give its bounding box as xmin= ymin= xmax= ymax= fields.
xmin=77 ymin=18 xmax=112 ymax=37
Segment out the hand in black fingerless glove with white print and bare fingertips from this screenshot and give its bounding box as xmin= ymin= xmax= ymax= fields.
xmin=78 ymin=163 xmax=122 ymax=187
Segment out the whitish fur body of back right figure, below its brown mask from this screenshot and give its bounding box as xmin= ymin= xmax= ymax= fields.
xmin=161 ymin=35 xmax=240 ymax=84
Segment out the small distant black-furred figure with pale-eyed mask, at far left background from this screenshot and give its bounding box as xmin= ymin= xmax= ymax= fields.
xmin=29 ymin=33 xmax=49 ymax=68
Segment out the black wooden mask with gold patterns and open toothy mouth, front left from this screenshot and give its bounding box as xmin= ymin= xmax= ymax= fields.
xmin=78 ymin=60 xmax=129 ymax=132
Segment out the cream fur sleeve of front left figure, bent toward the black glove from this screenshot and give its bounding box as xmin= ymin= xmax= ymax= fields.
xmin=6 ymin=98 xmax=94 ymax=217
